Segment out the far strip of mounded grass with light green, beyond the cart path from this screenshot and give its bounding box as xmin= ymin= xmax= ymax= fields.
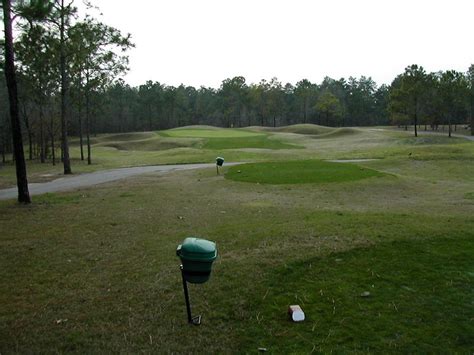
xmin=0 ymin=125 xmax=474 ymax=188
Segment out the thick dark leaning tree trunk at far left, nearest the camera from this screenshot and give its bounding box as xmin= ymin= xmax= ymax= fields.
xmin=2 ymin=0 xmax=31 ymax=203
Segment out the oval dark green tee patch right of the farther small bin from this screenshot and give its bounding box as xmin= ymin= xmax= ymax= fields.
xmin=226 ymin=160 xmax=385 ymax=184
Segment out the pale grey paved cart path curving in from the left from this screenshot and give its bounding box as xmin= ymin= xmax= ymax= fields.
xmin=0 ymin=163 xmax=240 ymax=200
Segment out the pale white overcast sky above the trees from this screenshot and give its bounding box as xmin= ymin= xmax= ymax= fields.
xmin=84 ymin=0 xmax=474 ymax=88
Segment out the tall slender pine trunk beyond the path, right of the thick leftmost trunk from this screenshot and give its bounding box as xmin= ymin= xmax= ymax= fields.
xmin=59 ymin=0 xmax=72 ymax=175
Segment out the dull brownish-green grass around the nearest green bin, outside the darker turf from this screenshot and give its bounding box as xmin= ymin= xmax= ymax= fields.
xmin=0 ymin=155 xmax=474 ymax=353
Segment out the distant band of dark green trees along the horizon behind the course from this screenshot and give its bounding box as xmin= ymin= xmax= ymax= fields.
xmin=0 ymin=65 xmax=474 ymax=154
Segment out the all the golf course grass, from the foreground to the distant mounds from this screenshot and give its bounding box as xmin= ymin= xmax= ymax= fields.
xmin=0 ymin=127 xmax=474 ymax=353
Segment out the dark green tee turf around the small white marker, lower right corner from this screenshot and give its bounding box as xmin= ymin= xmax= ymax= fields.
xmin=249 ymin=234 xmax=474 ymax=353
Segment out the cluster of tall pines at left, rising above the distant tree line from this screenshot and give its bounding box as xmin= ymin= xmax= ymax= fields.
xmin=0 ymin=0 xmax=133 ymax=203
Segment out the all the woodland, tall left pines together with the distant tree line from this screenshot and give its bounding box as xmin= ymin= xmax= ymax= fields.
xmin=0 ymin=0 xmax=474 ymax=177
